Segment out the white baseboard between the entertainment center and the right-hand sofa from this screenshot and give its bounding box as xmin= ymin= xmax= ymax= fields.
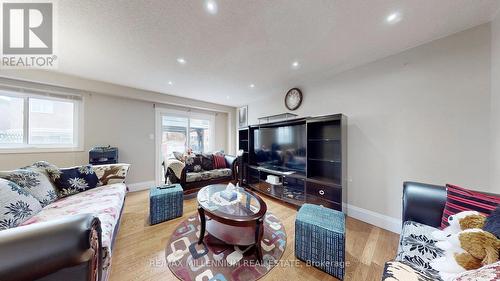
xmin=343 ymin=204 xmax=402 ymax=234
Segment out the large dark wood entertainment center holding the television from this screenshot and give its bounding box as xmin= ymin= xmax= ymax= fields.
xmin=238 ymin=114 xmax=347 ymax=210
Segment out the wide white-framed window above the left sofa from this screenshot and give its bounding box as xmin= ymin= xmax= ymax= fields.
xmin=0 ymin=90 xmax=82 ymax=152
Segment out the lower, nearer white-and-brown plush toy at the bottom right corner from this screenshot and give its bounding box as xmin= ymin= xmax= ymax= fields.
xmin=430 ymin=228 xmax=500 ymax=281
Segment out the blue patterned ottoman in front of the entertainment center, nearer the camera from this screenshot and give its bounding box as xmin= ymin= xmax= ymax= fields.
xmin=295 ymin=204 xmax=345 ymax=279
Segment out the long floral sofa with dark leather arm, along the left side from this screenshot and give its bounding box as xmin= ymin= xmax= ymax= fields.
xmin=0 ymin=164 xmax=129 ymax=280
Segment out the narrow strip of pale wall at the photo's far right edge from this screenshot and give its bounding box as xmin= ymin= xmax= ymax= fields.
xmin=490 ymin=13 xmax=500 ymax=189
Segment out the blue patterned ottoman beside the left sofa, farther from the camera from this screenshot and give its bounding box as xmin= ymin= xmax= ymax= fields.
xmin=149 ymin=184 xmax=183 ymax=224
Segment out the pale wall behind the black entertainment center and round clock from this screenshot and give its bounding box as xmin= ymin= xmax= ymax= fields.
xmin=248 ymin=24 xmax=490 ymax=221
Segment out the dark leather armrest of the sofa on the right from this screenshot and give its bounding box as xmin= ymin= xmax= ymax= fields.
xmin=403 ymin=182 xmax=446 ymax=227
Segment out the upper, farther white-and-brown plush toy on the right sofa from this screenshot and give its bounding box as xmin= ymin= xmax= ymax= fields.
xmin=432 ymin=211 xmax=486 ymax=241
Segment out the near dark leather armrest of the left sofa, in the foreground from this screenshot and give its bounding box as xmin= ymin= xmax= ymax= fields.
xmin=0 ymin=214 xmax=102 ymax=281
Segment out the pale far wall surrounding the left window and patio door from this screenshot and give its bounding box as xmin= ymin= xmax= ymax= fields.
xmin=0 ymin=70 xmax=235 ymax=184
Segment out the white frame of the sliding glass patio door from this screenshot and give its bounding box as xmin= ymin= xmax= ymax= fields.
xmin=155 ymin=107 xmax=215 ymax=185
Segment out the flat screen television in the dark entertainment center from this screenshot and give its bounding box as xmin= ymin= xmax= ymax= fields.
xmin=253 ymin=124 xmax=307 ymax=174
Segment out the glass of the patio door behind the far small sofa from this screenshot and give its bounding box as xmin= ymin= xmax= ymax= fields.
xmin=159 ymin=109 xmax=214 ymax=162
